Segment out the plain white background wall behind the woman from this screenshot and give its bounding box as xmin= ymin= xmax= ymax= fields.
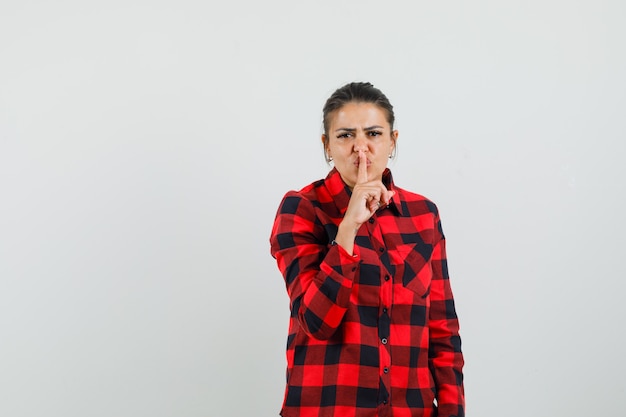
xmin=0 ymin=0 xmax=626 ymax=417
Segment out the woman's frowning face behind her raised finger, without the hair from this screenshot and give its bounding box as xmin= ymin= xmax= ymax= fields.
xmin=322 ymin=102 xmax=398 ymax=189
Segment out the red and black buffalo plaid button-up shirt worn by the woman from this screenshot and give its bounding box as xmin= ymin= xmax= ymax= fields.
xmin=270 ymin=169 xmax=465 ymax=417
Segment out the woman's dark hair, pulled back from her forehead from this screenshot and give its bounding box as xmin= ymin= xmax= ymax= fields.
xmin=323 ymin=82 xmax=395 ymax=162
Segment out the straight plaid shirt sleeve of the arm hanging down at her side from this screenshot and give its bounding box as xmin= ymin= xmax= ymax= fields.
xmin=429 ymin=207 xmax=465 ymax=417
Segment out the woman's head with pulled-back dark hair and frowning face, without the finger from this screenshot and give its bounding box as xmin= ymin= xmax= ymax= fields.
xmin=322 ymin=83 xmax=398 ymax=187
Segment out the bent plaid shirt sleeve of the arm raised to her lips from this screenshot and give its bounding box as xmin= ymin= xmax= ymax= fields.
xmin=270 ymin=191 xmax=360 ymax=340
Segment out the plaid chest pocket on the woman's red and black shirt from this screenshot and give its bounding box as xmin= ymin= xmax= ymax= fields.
xmin=392 ymin=242 xmax=433 ymax=298
